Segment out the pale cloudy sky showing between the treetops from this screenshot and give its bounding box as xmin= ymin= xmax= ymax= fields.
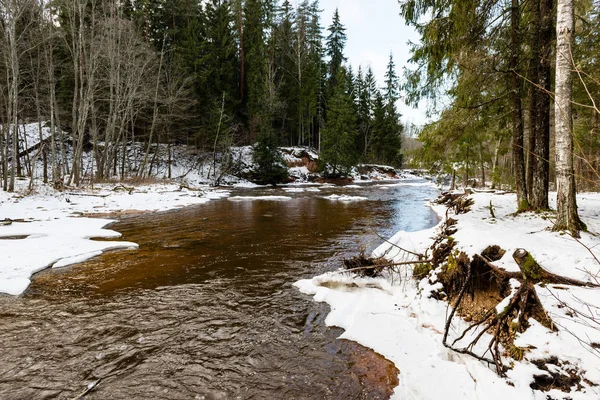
xmin=320 ymin=0 xmax=427 ymax=125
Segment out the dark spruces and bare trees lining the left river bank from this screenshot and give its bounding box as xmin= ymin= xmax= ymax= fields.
xmin=0 ymin=0 xmax=403 ymax=191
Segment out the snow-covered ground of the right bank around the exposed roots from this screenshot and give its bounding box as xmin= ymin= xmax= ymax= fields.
xmin=296 ymin=193 xmax=600 ymax=400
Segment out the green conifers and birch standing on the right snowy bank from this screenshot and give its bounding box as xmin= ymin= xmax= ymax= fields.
xmin=400 ymin=0 xmax=600 ymax=232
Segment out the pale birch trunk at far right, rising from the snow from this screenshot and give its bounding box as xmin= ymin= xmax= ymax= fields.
xmin=554 ymin=0 xmax=585 ymax=236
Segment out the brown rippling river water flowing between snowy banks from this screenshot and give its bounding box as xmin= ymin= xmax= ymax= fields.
xmin=0 ymin=185 xmax=437 ymax=399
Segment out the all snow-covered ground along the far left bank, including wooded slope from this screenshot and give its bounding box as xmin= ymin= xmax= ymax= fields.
xmin=0 ymin=123 xmax=418 ymax=294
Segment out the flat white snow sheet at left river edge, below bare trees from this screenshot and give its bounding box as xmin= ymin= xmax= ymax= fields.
xmin=0 ymin=181 xmax=230 ymax=295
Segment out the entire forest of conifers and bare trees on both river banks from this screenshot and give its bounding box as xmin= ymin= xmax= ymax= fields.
xmin=0 ymin=0 xmax=600 ymax=231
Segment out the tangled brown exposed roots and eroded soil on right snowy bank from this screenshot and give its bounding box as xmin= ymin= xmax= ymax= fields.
xmin=429 ymin=193 xmax=598 ymax=382
